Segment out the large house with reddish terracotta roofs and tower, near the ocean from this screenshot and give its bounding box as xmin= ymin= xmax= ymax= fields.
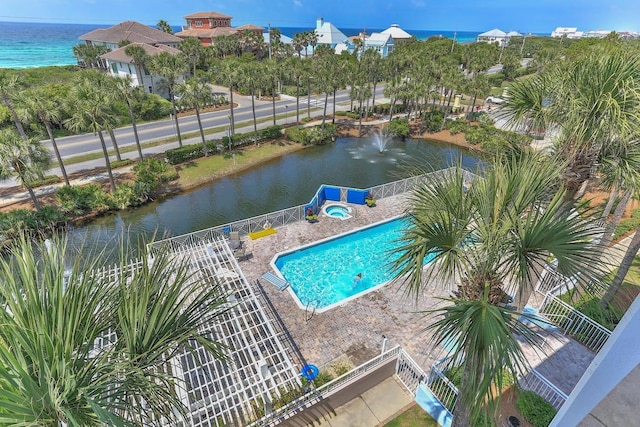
xmin=176 ymin=12 xmax=264 ymax=46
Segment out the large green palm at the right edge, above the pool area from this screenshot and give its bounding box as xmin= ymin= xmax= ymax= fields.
xmin=502 ymin=52 xmax=640 ymax=197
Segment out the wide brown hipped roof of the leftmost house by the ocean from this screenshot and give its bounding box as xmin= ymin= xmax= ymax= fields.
xmin=78 ymin=21 xmax=180 ymax=44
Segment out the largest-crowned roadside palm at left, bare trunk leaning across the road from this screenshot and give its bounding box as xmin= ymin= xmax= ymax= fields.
xmin=64 ymin=80 xmax=116 ymax=191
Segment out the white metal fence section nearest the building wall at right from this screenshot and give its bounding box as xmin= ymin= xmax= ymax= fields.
xmin=539 ymin=293 xmax=611 ymax=353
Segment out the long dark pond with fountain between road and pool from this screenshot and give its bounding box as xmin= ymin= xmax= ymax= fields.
xmin=69 ymin=138 xmax=480 ymax=256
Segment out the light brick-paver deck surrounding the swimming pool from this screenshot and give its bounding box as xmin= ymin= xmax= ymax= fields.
xmin=235 ymin=195 xmax=594 ymax=393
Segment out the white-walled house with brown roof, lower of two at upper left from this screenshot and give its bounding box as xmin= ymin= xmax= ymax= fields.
xmin=100 ymin=43 xmax=180 ymax=98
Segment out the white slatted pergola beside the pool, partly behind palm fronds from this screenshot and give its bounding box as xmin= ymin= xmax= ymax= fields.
xmin=95 ymin=238 xmax=301 ymax=427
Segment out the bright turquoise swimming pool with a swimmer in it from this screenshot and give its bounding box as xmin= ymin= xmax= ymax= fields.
xmin=271 ymin=218 xmax=436 ymax=312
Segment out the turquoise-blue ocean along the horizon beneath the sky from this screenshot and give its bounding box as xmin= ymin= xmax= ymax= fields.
xmin=0 ymin=22 xmax=479 ymax=68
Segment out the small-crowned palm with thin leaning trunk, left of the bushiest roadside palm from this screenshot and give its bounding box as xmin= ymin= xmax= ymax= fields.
xmin=20 ymin=87 xmax=69 ymax=185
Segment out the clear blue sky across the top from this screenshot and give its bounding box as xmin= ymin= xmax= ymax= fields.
xmin=0 ymin=0 xmax=640 ymax=34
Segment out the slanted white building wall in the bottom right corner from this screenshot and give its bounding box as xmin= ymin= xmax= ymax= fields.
xmin=550 ymin=298 xmax=640 ymax=427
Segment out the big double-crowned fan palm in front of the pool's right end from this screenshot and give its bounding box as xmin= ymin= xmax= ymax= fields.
xmin=394 ymin=153 xmax=600 ymax=427
